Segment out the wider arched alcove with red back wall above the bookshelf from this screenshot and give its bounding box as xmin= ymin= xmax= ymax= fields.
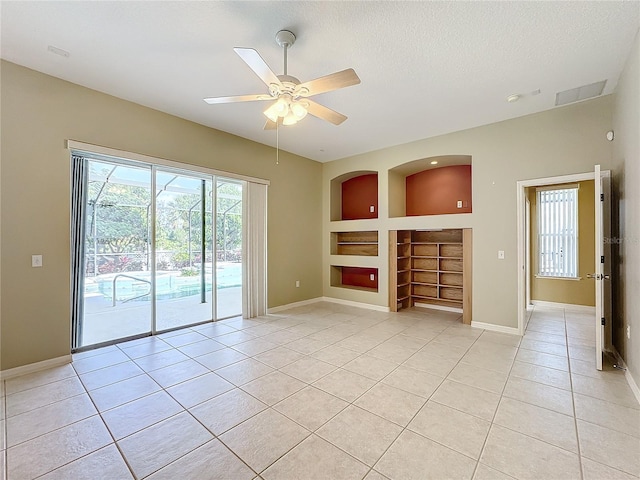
xmin=389 ymin=155 xmax=473 ymax=217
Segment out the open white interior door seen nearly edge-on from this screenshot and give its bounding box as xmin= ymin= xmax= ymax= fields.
xmin=592 ymin=165 xmax=611 ymax=370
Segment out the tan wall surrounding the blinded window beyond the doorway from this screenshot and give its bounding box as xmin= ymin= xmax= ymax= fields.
xmin=528 ymin=180 xmax=596 ymax=307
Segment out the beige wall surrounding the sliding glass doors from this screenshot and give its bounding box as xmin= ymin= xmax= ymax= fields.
xmin=0 ymin=62 xmax=322 ymax=370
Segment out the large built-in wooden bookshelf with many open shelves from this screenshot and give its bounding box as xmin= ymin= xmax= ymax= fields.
xmin=389 ymin=229 xmax=471 ymax=324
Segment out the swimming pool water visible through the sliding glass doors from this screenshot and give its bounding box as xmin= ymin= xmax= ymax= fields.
xmin=84 ymin=263 xmax=242 ymax=301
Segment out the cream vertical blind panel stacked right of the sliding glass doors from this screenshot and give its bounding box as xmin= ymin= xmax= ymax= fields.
xmin=242 ymin=182 xmax=267 ymax=318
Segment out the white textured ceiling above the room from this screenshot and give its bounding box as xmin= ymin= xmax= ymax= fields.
xmin=0 ymin=1 xmax=640 ymax=162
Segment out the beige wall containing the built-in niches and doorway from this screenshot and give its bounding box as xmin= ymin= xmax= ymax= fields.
xmin=322 ymin=96 xmax=612 ymax=328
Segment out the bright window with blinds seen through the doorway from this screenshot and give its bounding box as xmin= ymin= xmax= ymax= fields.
xmin=537 ymin=186 xmax=578 ymax=278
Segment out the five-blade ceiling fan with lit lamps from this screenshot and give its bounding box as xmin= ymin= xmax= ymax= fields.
xmin=204 ymin=30 xmax=360 ymax=130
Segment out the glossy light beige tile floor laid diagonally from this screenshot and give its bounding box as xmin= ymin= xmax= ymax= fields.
xmin=0 ymin=303 xmax=640 ymax=480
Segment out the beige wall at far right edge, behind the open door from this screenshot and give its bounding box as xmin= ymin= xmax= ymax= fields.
xmin=612 ymin=31 xmax=640 ymax=386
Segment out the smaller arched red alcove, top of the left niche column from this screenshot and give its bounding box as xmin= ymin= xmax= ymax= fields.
xmin=331 ymin=170 xmax=378 ymax=221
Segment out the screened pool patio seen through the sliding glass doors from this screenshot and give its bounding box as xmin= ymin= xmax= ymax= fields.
xmin=73 ymin=156 xmax=244 ymax=348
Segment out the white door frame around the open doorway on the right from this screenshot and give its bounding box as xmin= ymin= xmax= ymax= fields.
xmin=516 ymin=171 xmax=595 ymax=335
